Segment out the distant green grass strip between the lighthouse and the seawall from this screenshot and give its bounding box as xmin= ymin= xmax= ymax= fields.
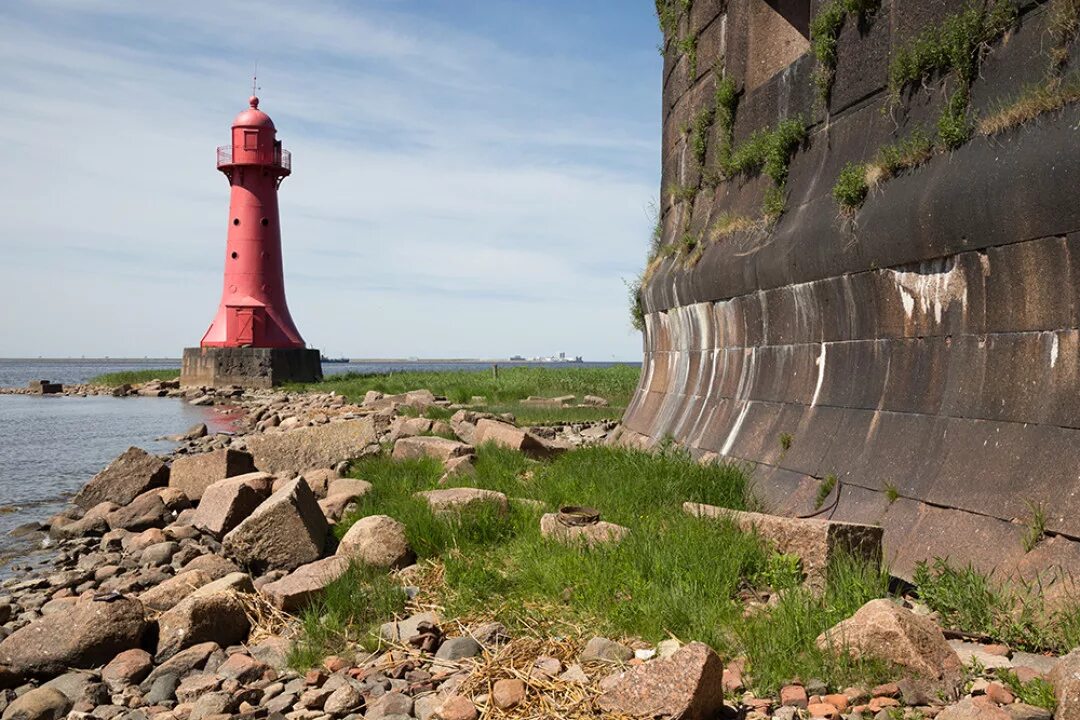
xmin=286 ymin=365 xmax=640 ymax=424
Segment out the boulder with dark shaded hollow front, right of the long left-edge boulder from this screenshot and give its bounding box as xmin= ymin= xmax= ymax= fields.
xmin=154 ymin=573 xmax=255 ymax=663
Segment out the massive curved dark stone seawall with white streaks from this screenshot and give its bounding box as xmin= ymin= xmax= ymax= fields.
xmin=624 ymin=0 xmax=1080 ymax=576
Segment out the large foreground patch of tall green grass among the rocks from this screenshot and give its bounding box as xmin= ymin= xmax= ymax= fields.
xmin=294 ymin=445 xmax=902 ymax=691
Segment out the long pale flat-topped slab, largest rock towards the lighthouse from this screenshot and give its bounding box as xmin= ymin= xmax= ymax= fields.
xmin=244 ymin=418 xmax=376 ymax=477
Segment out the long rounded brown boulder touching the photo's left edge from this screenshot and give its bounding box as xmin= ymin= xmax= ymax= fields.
xmin=0 ymin=598 xmax=147 ymax=679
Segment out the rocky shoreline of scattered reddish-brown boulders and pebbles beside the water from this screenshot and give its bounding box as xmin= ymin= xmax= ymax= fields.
xmin=0 ymin=382 xmax=1080 ymax=720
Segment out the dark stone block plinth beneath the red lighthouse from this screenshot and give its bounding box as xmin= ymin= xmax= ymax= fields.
xmin=180 ymin=348 xmax=323 ymax=389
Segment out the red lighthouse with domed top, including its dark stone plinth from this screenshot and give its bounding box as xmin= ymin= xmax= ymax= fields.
xmin=181 ymin=95 xmax=322 ymax=386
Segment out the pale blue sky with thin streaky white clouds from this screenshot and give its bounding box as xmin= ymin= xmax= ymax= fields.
xmin=0 ymin=0 xmax=662 ymax=361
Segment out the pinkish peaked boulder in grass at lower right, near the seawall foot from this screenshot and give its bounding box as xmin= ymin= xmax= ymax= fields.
xmin=818 ymin=599 xmax=963 ymax=695
